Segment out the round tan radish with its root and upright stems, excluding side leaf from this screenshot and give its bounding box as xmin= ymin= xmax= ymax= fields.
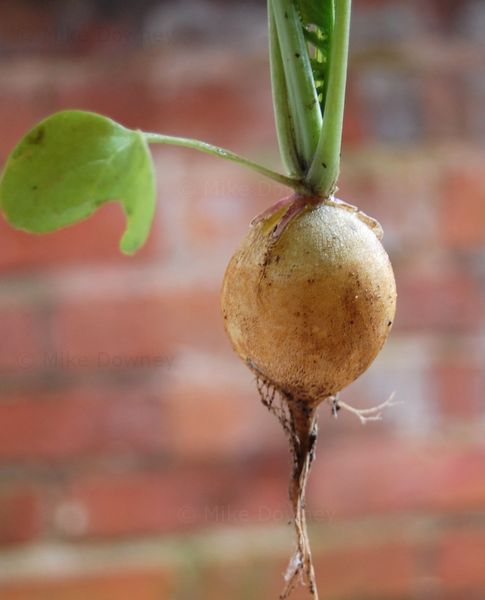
xmin=221 ymin=0 xmax=396 ymax=599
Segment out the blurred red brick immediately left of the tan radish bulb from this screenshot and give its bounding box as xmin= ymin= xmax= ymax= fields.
xmin=53 ymin=286 xmax=229 ymax=364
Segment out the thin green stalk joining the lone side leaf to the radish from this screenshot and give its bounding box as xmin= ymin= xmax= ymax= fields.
xmin=142 ymin=132 xmax=307 ymax=192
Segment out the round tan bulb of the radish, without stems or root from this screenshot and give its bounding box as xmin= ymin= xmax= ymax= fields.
xmin=222 ymin=201 xmax=396 ymax=404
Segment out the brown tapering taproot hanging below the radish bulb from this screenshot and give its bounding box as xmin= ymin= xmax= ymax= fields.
xmin=257 ymin=377 xmax=318 ymax=600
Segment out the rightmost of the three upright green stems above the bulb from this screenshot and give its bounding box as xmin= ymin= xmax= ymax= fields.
xmin=306 ymin=0 xmax=352 ymax=198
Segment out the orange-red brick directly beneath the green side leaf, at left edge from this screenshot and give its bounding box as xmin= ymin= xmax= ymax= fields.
xmin=0 ymin=204 xmax=163 ymax=272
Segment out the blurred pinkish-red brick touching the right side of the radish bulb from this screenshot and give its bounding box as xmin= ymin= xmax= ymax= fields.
xmin=395 ymin=270 xmax=482 ymax=331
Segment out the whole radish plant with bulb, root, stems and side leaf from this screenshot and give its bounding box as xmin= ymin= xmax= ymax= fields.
xmin=0 ymin=0 xmax=396 ymax=599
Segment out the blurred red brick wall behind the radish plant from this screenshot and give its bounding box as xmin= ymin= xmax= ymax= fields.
xmin=0 ymin=0 xmax=485 ymax=600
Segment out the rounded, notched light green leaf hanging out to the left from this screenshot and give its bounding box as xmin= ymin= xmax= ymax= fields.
xmin=0 ymin=111 xmax=155 ymax=254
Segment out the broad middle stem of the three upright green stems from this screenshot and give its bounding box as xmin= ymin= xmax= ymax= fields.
xmin=271 ymin=0 xmax=322 ymax=172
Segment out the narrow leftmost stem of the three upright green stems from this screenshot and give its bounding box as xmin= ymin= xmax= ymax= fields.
xmin=268 ymin=0 xmax=303 ymax=177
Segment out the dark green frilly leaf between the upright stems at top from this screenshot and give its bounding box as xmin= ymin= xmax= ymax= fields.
xmin=295 ymin=0 xmax=335 ymax=115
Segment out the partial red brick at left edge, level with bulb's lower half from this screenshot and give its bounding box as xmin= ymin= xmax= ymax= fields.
xmin=0 ymin=307 xmax=44 ymax=373
